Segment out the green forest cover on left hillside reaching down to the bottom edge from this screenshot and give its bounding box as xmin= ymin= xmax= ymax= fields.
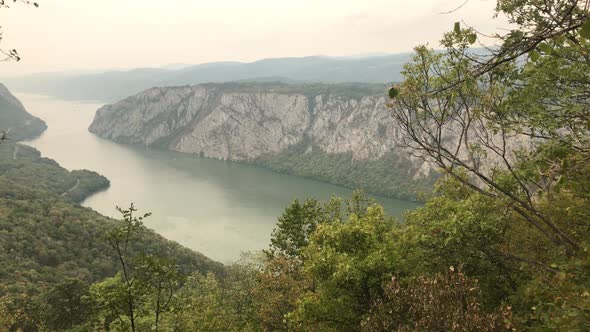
xmin=0 ymin=144 xmax=223 ymax=331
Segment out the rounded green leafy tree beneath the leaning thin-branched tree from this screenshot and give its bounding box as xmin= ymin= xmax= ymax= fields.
xmin=403 ymin=177 xmax=524 ymax=305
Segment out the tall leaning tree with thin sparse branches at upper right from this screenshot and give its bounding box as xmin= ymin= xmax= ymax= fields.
xmin=390 ymin=0 xmax=590 ymax=255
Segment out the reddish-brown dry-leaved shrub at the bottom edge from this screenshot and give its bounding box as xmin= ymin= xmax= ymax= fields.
xmin=362 ymin=266 xmax=511 ymax=332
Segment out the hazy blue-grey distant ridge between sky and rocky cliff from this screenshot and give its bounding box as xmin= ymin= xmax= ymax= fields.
xmin=5 ymin=53 xmax=410 ymax=102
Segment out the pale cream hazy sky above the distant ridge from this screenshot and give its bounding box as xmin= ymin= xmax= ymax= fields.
xmin=0 ymin=0 xmax=503 ymax=75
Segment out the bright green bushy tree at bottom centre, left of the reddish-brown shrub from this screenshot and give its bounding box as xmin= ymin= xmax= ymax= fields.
xmin=293 ymin=205 xmax=398 ymax=330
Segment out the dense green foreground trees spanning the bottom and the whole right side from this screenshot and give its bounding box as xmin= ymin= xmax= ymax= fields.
xmin=0 ymin=0 xmax=590 ymax=331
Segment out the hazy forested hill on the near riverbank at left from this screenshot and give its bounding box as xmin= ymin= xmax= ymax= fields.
xmin=0 ymin=143 xmax=222 ymax=302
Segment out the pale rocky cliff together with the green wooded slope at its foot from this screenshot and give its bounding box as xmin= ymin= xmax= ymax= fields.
xmin=89 ymin=83 xmax=435 ymax=199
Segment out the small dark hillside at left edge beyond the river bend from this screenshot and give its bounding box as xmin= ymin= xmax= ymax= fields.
xmin=0 ymin=83 xmax=47 ymax=142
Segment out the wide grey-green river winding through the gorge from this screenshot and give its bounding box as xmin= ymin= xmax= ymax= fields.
xmin=16 ymin=93 xmax=416 ymax=262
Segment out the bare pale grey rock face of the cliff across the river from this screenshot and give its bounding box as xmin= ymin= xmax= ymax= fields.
xmin=89 ymin=84 xmax=438 ymax=200
